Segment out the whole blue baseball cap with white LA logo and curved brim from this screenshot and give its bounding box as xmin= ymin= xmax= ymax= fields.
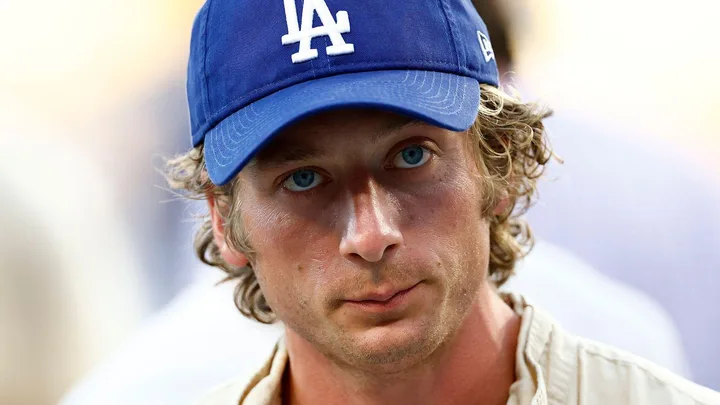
xmin=187 ymin=0 xmax=498 ymax=185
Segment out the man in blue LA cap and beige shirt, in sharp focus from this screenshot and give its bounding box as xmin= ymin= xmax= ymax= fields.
xmin=168 ymin=0 xmax=720 ymax=404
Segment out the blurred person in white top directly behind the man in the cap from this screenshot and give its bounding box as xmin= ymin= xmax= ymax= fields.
xmin=57 ymin=1 xmax=688 ymax=405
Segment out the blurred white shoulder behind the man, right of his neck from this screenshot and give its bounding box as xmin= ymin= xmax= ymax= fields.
xmin=503 ymin=240 xmax=689 ymax=376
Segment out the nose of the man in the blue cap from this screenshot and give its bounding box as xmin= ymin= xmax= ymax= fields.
xmin=340 ymin=182 xmax=403 ymax=262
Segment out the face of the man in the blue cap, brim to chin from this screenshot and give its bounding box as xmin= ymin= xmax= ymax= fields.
xmin=233 ymin=110 xmax=488 ymax=369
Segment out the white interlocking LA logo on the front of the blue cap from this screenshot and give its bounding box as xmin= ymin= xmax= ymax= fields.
xmin=282 ymin=0 xmax=355 ymax=63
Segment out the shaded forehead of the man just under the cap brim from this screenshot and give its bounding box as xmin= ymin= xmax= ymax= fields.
xmin=249 ymin=109 xmax=422 ymax=166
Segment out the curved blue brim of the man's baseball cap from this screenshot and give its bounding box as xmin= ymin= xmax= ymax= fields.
xmin=205 ymin=70 xmax=480 ymax=185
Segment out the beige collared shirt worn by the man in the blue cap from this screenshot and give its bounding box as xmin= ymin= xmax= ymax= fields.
xmin=202 ymin=294 xmax=720 ymax=405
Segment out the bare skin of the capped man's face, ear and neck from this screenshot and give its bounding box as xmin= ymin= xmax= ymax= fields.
xmin=209 ymin=110 xmax=519 ymax=404
